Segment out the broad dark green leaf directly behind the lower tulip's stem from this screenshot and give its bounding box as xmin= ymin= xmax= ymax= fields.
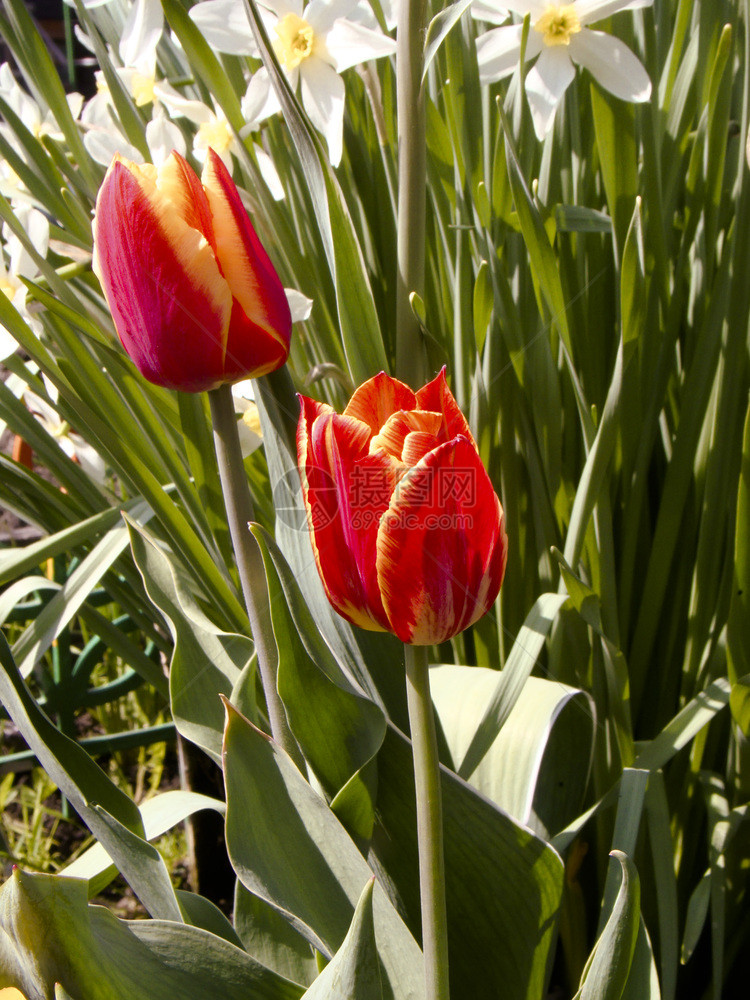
xmin=373 ymin=726 xmax=564 ymax=1000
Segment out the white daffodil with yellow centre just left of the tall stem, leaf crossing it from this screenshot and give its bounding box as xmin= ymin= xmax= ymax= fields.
xmin=190 ymin=0 xmax=396 ymax=166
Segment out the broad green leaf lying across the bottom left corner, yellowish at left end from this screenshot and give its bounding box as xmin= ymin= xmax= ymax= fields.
xmin=0 ymin=870 xmax=303 ymax=1000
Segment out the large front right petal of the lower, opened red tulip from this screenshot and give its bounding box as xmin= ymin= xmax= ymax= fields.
xmin=376 ymin=437 xmax=507 ymax=645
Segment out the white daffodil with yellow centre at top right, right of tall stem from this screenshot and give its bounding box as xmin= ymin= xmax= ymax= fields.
xmin=477 ymin=0 xmax=653 ymax=139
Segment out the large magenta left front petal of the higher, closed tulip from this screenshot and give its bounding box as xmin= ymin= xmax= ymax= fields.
xmin=94 ymin=160 xmax=232 ymax=392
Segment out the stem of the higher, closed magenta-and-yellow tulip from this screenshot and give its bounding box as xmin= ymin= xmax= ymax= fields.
xmin=208 ymin=385 xmax=304 ymax=769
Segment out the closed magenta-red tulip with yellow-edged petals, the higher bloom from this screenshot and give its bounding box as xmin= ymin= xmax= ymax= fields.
xmin=94 ymin=150 xmax=291 ymax=392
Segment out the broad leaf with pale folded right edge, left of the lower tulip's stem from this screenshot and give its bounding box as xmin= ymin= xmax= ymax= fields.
xmin=224 ymin=704 xmax=424 ymax=1000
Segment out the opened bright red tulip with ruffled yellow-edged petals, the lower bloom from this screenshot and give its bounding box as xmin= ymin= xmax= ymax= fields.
xmin=297 ymin=370 xmax=508 ymax=645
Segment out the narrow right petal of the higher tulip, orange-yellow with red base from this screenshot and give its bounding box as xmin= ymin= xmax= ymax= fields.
xmin=202 ymin=149 xmax=292 ymax=376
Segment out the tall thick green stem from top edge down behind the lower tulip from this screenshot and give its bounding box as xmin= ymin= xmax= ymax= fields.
xmin=396 ymin=0 xmax=427 ymax=385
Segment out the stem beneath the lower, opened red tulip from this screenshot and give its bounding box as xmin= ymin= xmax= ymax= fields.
xmin=405 ymin=645 xmax=449 ymax=1000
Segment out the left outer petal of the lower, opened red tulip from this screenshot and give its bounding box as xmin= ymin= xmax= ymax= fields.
xmin=297 ymin=397 xmax=395 ymax=631
